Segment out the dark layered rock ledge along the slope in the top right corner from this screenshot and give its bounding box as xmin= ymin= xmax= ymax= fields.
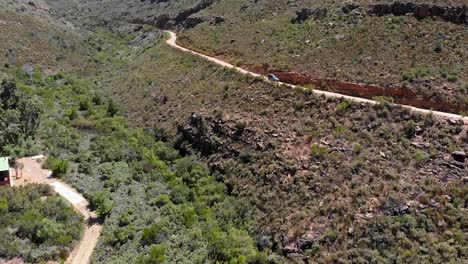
xmin=367 ymin=2 xmax=468 ymax=24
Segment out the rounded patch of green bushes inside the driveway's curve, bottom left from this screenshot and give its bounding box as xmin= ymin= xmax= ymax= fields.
xmin=0 ymin=184 xmax=84 ymax=263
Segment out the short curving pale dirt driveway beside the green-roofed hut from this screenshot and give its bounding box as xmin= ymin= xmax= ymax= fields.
xmin=13 ymin=156 xmax=102 ymax=264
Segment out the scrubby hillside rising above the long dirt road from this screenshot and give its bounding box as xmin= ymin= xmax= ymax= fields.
xmin=46 ymin=0 xmax=468 ymax=113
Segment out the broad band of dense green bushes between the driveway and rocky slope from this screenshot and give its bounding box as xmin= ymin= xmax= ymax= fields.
xmin=8 ymin=68 xmax=266 ymax=263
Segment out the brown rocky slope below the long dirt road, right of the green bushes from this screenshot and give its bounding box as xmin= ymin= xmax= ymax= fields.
xmin=96 ymin=27 xmax=468 ymax=262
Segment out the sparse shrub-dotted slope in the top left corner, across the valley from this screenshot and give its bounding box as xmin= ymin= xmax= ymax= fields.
xmin=0 ymin=0 xmax=87 ymax=74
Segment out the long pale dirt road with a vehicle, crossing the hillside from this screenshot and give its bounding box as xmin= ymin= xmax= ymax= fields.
xmin=164 ymin=30 xmax=468 ymax=124
